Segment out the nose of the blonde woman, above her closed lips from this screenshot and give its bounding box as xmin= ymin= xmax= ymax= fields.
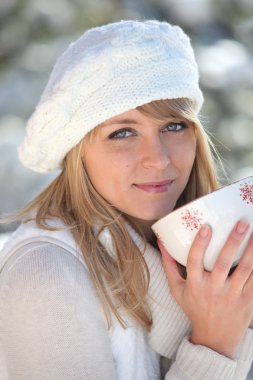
xmin=142 ymin=138 xmax=171 ymax=171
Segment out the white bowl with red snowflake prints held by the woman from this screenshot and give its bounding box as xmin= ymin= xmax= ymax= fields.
xmin=152 ymin=176 xmax=253 ymax=271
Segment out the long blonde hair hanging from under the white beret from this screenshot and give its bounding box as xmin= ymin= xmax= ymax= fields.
xmin=4 ymin=98 xmax=220 ymax=330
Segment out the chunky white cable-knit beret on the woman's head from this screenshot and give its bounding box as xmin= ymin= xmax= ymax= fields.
xmin=19 ymin=20 xmax=203 ymax=172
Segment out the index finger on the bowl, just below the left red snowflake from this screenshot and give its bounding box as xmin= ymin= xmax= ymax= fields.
xmin=186 ymin=224 xmax=212 ymax=281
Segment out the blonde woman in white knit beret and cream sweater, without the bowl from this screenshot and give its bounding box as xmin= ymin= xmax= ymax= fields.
xmin=0 ymin=21 xmax=253 ymax=380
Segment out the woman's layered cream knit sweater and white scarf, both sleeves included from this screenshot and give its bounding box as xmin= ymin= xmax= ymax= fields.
xmin=0 ymin=221 xmax=253 ymax=380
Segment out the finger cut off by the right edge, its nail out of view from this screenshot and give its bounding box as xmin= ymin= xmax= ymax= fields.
xmin=234 ymin=233 xmax=253 ymax=299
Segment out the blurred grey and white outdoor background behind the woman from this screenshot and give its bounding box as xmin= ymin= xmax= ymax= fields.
xmin=0 ymin=0 xmax=253 ymax=233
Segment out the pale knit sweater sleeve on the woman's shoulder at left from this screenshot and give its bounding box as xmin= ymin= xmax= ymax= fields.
xmin=0 ymin=243 xmax=116 ymax=380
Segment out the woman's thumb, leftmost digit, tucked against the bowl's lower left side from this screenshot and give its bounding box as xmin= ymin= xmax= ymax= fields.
xmin=157 ymin=240 xmax=185 ymax=299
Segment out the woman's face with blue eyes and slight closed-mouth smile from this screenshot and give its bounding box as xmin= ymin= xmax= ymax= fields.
xmin=84 ymin=110 xmax=196 ymax=229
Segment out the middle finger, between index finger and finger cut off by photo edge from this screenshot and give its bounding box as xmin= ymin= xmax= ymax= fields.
xmin=212 ymin=220 xmax=249 ymax=284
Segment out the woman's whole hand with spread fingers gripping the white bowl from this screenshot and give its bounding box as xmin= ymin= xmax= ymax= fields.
xmin=158 ymin=221 xmax=253 ymax=358
